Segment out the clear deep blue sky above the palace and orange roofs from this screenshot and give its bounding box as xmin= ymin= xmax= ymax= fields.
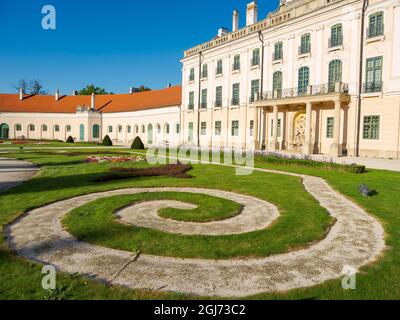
xmin=0 ymin=0 xmax=279 ymax=94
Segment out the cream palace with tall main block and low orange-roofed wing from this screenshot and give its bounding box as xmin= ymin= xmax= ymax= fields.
xmin=0 ymin=0 xmax=400 ymax=159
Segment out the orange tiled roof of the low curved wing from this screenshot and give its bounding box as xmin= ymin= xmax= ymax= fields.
xmin=0 ymin=86 xmax=182 ymax=113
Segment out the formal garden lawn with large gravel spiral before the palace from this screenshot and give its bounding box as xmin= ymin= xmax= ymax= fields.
xmin=0 ymin=144 xmax=400 ymax=299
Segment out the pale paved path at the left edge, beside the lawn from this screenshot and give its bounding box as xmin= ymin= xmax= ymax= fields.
xmin=0 ymin=158 xmax=38 ymax=193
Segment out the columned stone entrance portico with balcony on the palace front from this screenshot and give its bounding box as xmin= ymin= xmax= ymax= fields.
xmin=253 ymin=82 xmax=350 ymax=157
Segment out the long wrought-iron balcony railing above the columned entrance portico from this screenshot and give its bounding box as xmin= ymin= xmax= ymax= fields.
xmin=261 ymin=82 xmax=349 ymax=101
